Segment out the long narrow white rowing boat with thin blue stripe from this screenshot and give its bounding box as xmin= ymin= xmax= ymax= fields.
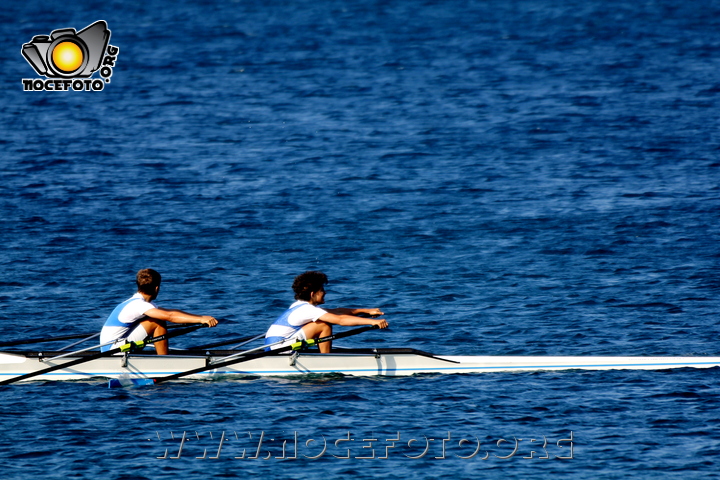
xmin=0 ymin=348 xmax=720 ymax=381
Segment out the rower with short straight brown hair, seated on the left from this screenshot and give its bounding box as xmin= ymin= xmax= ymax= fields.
xmin=100 ymin=268 xmax=218 ymax=355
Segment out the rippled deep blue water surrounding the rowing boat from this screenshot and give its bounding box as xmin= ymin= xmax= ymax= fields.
xmin=0 ymin=0 xmax=720 ymax=480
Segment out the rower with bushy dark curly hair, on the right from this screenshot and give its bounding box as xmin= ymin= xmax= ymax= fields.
xmin=265 ymin=271 xmax=388 ymax=353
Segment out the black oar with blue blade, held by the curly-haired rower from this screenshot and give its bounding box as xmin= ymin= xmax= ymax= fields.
xmin=108 ymin=325 xmax=378 ymax=388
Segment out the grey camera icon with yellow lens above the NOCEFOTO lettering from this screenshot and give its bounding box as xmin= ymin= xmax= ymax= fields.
xmin=22 ymin=20 xmax=110 ymax=79
